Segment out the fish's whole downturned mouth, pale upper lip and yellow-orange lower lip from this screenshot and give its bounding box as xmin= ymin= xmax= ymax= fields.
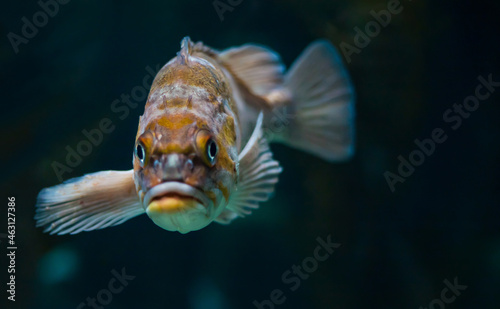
xmin=144 ymin=181 xmax=213 ymax=214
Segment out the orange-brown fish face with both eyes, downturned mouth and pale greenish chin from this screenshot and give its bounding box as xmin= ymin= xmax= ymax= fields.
xmin=134 ymin=114 xmax=237 ymax=233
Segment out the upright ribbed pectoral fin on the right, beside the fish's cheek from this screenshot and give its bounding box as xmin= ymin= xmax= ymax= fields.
xmin=216 ymin=113 xmax=282 ymax=223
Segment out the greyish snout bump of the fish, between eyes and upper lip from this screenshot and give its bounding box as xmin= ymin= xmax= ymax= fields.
xmin=154 ymin=153 xmax=194 ymax=181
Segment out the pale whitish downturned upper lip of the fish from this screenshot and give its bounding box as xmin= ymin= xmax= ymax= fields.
xmin=143 ymin=181 xmax=211 ymax=209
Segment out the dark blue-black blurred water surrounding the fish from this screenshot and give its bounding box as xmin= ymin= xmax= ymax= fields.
xmin=0 ymin=0 xmax=500 ymax=309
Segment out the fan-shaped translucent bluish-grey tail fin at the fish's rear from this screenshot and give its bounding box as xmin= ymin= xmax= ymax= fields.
xmin=277 ymin=40 xmax=355 ymax=161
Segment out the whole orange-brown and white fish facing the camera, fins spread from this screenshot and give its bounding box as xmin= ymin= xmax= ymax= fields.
xmin=35 ymin=37 xmax=355 ymax=235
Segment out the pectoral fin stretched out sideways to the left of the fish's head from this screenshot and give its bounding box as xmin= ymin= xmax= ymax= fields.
xmin=35 ymin=170 xmax=144 ymax=235
